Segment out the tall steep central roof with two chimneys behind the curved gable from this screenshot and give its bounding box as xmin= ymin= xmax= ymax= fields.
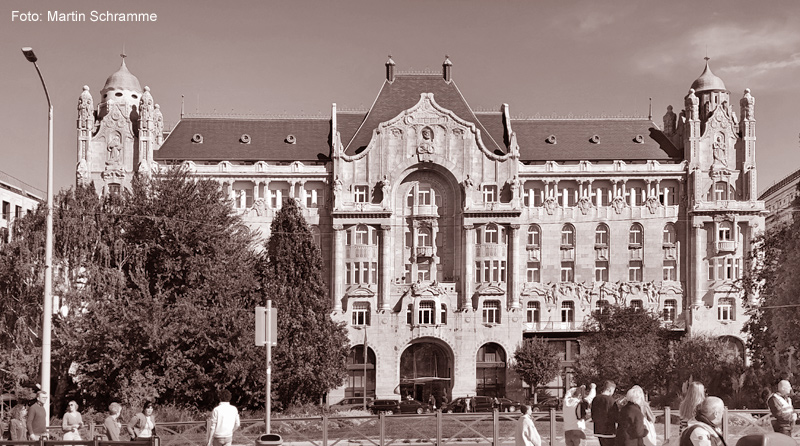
xmin=340 ymin=74 xmax=508 ymax=155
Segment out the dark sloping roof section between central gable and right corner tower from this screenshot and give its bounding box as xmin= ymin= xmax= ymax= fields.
xmin=511 ymin=118 xmax=683 ymax=162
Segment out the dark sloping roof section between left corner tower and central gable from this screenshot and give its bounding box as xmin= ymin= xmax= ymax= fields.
xmin=153 ymin=117 xmax=331 ymax=161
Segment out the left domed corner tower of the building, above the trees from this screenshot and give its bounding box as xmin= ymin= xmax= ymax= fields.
xmin=76 ymin=54 xmax=163 ymax=194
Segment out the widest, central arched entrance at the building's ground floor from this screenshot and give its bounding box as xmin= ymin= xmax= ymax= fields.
xmin=399 ymin=339 xmax=453 ymax=406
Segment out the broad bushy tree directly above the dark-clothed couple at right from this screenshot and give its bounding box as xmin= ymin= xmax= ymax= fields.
xmin=575 ymin=305 xmax=668 ymax=391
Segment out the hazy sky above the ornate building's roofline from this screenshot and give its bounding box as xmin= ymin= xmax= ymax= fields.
xmin=0 ymin=0 xmax=800 ymax=195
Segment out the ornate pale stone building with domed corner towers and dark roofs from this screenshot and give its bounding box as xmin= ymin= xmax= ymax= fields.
xmin=78 ymin=58 xmax=765 ymax=401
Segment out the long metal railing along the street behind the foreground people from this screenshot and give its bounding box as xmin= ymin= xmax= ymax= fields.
xmin=0 ymin=408 xmax=800 ymax=446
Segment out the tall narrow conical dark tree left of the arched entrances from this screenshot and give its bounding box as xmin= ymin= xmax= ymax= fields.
xmin=262 ymin=199 xmax=350 ymax=406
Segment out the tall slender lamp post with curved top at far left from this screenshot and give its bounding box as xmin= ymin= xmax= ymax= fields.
xmin=22 ymin=47 xmax=53 ymax=420
